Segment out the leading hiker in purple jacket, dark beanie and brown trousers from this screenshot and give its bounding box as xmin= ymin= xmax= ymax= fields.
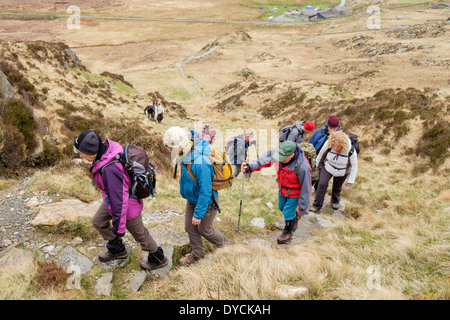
xmin=73 ymin=129 xmax=168 ymax=270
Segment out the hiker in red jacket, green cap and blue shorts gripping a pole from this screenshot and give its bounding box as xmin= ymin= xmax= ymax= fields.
xmin=242 ymin=141 xmax=311 ymax=244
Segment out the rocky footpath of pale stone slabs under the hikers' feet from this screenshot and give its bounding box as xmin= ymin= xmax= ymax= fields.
xmin=0 ymin=179 xmax=345 ymax=296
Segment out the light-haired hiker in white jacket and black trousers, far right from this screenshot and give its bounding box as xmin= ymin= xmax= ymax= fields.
xmin=309 ymin=131 xmax=358 ymax=212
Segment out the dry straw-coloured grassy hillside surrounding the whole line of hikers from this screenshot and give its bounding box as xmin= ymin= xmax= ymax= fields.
xmin=0 ymin=0 xmax=450 ymax=300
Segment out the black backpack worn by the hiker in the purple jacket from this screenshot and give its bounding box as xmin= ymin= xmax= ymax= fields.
xmin=101 ymin=144 xmax=156 ymax=199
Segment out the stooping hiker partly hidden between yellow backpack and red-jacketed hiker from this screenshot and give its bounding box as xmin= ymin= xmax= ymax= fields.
xmin=226 ymin=129 xmax=256 ymax=178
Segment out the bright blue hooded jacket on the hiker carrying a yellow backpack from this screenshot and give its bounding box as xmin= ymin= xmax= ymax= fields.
xmin=180 ymin=138 xmax=218 ymax=219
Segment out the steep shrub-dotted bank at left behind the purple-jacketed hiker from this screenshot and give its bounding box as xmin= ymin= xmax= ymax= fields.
xmin=0 ymin=42 xmax=186 ymax=176
